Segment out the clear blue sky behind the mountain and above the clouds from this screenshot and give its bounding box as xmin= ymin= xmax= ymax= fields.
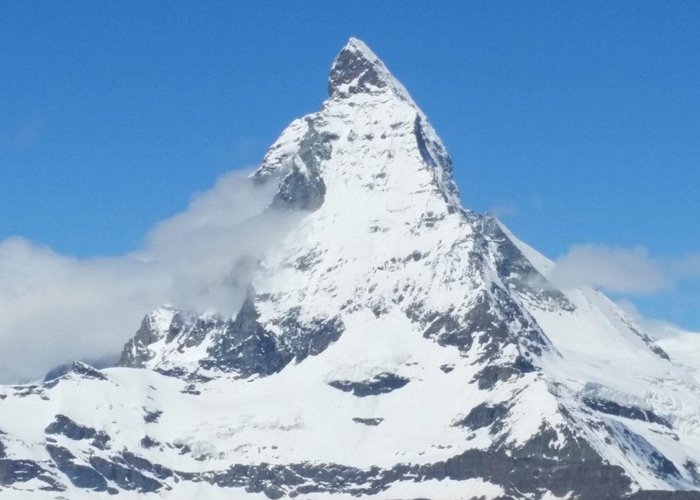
xmin=0 ymin=0 xmax=700 ymax=329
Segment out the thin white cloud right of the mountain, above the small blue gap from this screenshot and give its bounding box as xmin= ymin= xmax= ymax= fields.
xmin=549 ymin=244 xmax=700 ymax=294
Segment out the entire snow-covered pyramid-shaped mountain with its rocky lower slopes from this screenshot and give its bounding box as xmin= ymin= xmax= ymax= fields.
xmin=0 ymin=39 xmax=700 ymax=499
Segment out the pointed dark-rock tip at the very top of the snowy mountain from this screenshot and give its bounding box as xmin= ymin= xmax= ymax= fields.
xmin=328 ymin=37 xmax=410 ymax=100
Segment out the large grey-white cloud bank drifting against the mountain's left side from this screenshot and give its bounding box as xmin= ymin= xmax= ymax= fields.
xmin=0 ymin=171 xmax=298 ymax=382
